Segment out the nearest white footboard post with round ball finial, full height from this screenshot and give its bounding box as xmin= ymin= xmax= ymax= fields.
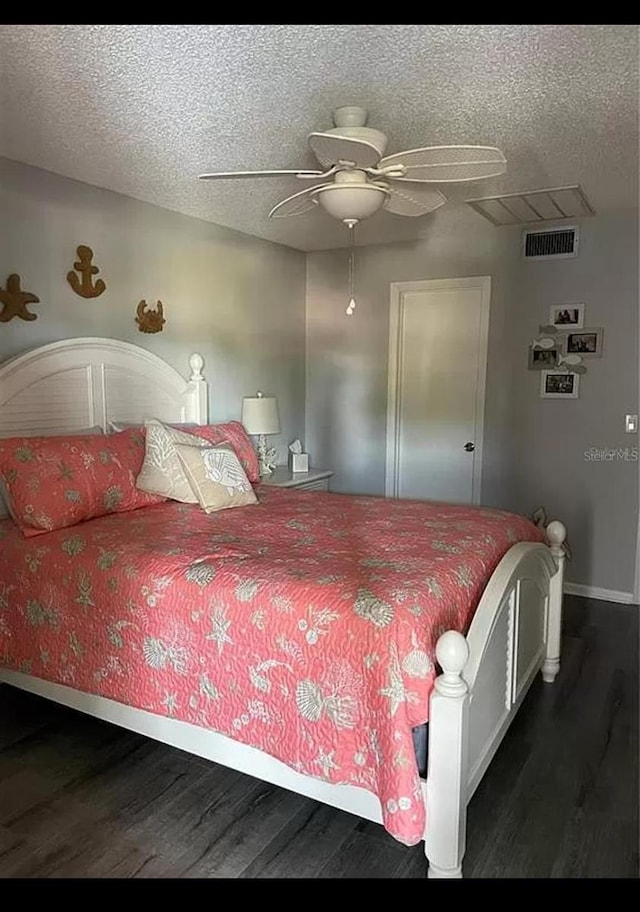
xmin=425 ymin=630 xmax=469 ymax=878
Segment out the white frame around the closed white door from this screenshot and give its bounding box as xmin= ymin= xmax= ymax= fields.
xmin=385 ymin=276 xmax=491 ymax=504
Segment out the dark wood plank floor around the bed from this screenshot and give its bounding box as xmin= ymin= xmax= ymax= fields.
xmin=0 ymin=597 xmax=638 ymax=878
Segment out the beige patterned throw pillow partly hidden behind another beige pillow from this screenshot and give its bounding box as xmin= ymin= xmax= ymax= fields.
xmin=136 ymin=418 xmax=210 ymax=503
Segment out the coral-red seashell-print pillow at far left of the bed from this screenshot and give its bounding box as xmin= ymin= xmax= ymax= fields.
xmin=0 ymin=429 xmax=164 ymax=538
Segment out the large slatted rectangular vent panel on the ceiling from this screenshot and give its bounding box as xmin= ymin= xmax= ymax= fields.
xmin=466 ymin=184 xmax=595 ymax=227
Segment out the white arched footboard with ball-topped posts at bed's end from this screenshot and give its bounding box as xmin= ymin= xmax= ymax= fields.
xmin=425 ymin=522 xmax=566 ymax=877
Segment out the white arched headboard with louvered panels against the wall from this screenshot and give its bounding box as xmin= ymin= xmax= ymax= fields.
xmin=0 ymin=339 xmax=208 ymax=437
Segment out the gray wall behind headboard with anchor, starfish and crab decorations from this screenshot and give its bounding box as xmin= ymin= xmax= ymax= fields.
xmin=0 ymin=159 xmax=305 ymax=461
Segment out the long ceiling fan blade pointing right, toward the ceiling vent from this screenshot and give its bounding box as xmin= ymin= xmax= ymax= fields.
xmin=378 ymin=146 xmax=507 ymax=183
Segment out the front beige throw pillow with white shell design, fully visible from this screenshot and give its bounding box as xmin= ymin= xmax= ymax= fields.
xmin=175 ymin=443 xmax=258 ymax=513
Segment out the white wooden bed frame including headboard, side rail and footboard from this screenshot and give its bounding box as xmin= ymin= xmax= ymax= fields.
xmin=0 ymin=339 xmax=566 ymax=878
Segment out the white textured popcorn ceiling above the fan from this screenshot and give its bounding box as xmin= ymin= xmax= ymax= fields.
xmin=0 ymin=25 xmax=638 ymax=250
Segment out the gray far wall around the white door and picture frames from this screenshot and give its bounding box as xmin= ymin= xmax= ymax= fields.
xmin=306 ymin=210 xmax=638 ymax=593
